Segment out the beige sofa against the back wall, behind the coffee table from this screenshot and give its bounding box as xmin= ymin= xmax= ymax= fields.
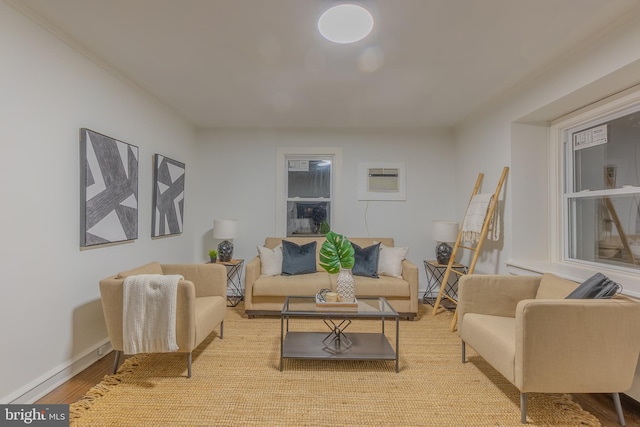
xmin=245 ymin=236 xmax=418 ymax=319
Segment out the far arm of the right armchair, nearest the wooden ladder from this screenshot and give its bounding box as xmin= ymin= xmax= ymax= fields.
xmin=458 ymin=274 xmax=541 ymax=326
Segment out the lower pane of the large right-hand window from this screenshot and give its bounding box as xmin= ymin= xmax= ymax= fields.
xmin=568 ymin=194 xmax=640 ymax=268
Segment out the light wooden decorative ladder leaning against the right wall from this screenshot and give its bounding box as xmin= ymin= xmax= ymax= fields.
xmin=432 ymin=166 xmax=509 ymax=331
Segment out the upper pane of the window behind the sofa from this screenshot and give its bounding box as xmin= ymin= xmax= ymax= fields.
xmin=287 ymin=159 xmax=331 ymax=199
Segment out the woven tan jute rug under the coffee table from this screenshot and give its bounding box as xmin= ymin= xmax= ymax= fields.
xmin=70 ymin=304 xmax=600 ymax=427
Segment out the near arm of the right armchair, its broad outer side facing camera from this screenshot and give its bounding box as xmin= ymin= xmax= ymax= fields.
xmin=515 ymin=297 xmax=640 ymax=393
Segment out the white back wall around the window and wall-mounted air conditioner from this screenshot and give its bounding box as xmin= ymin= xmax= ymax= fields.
xmin=195 ymin=130 xmax=458 ymax=287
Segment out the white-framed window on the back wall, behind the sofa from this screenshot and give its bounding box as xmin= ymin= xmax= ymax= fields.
xmin=277 ymin=147 xmax=341 ymax=236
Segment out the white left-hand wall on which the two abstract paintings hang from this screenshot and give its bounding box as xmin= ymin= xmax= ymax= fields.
xmin=0 ymin=2 xmax=196 ymax=403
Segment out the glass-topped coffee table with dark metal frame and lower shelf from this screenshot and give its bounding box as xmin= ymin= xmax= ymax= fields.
xmin=280 ymin=296 xmax=400 ymax=372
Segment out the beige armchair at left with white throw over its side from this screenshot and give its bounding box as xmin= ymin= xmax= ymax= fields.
xmin=100 ymin=262 xmax=227 ymax=378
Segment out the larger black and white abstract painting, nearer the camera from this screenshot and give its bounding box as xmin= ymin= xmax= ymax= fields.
xmin=80 ymin=128 xmax=138 ymax=247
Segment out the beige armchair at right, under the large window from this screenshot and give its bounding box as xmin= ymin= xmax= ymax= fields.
xmin=458 ymin=274 xmax=640 ymax=425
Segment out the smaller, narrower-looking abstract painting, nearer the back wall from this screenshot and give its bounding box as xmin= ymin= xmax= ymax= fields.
xmin=151 ymin=154 xmax=185 ymax=237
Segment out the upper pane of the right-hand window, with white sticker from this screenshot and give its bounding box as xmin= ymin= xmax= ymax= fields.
xmin=571 ymin=112 xmax=640 ymax=192
